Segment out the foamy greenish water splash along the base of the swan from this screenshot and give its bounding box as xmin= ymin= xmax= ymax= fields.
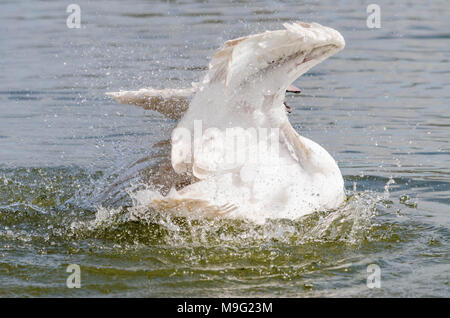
xmin=71 ymin=185 xmax=382 ymax=247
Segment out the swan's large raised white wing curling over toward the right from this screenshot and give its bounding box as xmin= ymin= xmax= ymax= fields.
xmin=171 ymin=22 xmax=345 ymax=179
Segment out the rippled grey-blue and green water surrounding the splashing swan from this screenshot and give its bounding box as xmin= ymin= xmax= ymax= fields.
xmin=0 ymin=1 xmax=450 ymax=297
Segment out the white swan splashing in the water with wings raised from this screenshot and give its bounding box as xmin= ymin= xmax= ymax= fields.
xmin=109 ymin=22 xmax=345 ymax=222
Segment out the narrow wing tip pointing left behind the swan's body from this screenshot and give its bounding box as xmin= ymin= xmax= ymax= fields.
xmin=106 ymin=83 xmax=198 ymax=119
